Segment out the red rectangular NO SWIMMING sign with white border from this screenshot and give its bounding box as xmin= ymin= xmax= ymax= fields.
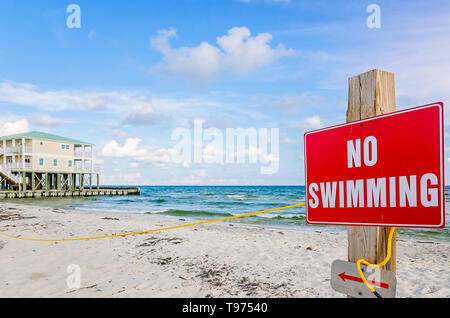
xmin=304 ymin=103 xmax=445 ymax=228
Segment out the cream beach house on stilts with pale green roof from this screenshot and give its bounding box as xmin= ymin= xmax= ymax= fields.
xmin=0 ymin=131 xmax=100 ymax=192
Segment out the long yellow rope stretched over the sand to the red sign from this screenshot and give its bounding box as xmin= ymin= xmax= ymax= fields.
xmin=0 ymin=203 xmax=306 ymax=242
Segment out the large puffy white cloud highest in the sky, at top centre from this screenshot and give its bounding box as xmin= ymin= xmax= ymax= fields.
xmin=151 ymin=27 xmax=297 ymax=85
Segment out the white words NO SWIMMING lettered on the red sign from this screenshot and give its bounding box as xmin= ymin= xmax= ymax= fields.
xmin=308 ymin=136 xmax=439 ymax=208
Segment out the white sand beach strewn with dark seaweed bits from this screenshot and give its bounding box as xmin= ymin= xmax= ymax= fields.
xmin=0 ymin=203 xmax=450 ymax=297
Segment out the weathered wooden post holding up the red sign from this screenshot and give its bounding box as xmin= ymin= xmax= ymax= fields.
xmin=347 ymin=70 xmax=397 ymax=273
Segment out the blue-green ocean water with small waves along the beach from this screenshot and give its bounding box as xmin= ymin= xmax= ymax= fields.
xmin=4 ymin=186 xmax=450 ymax=242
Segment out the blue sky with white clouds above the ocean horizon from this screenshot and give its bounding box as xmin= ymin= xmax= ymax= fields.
xmin=0 ymin=0 xmax=450 ymax=184
